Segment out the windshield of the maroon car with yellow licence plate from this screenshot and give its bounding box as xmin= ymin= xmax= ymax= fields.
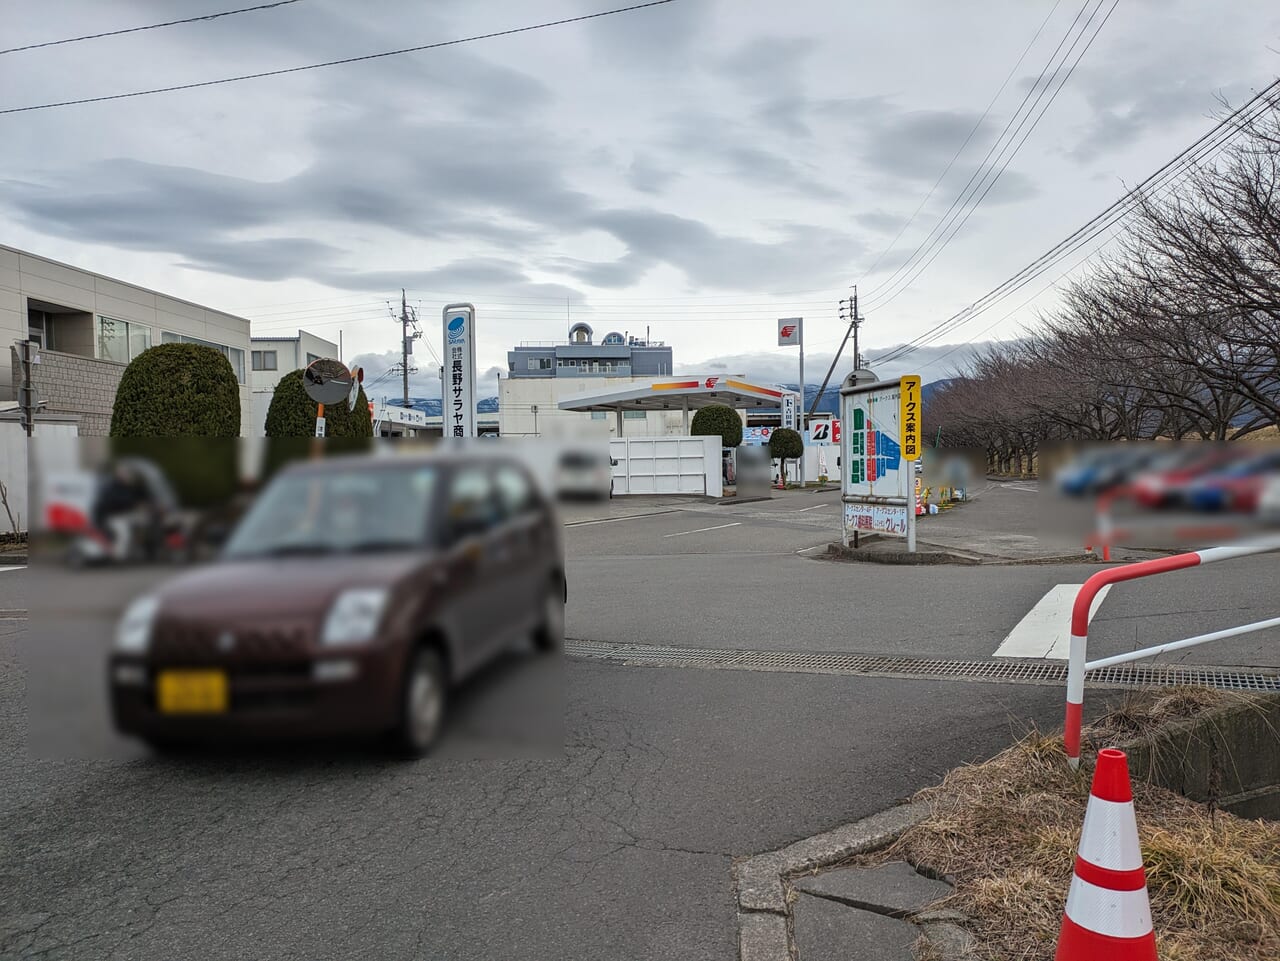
xmin=223 ymin=466 xmax=438 ymax=559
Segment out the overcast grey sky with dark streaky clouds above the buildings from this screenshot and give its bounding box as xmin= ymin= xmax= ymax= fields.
xmin=0 ymin=0 xmax=1280 ymax=394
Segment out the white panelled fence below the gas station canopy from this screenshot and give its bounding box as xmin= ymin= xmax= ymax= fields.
xmin=609 ymin=438 xmax=724 ymax=498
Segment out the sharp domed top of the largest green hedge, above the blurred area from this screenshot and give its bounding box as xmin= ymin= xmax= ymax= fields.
xmin=111 ymin=344 xmax=241 ymax=438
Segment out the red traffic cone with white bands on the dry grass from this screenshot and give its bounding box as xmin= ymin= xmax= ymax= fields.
xmin=1053 ymin=747 xmax=1156 ymax=961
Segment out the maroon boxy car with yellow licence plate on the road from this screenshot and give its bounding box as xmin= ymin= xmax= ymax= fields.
xmin=110 ymin=454 xmax=567 ymax=755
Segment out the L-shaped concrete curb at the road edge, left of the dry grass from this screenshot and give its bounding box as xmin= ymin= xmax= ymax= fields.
xmin=733 ymin=802 xmax=932 ymax=961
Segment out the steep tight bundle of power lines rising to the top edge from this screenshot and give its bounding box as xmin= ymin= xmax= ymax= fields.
xmin=868 ymin=0 xmax=1119 ymax=308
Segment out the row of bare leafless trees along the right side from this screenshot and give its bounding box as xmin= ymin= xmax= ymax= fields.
xmin=924 ymin=99 xmax=1280 ymax=472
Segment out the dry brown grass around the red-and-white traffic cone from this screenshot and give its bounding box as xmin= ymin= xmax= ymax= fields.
xmin=864 ymin=688 xmax=1280 ymax=961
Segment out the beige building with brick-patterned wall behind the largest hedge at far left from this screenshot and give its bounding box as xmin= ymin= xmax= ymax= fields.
xmin=0 ymin=246 xmax=252 ymax=436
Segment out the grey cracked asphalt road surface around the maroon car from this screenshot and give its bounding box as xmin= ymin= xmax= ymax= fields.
xmin=0 ymin=491 xmax=1280 ymax=961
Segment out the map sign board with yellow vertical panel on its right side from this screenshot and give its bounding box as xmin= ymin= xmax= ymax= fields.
xmin=840 ymin=376 xmax=922 ymax=550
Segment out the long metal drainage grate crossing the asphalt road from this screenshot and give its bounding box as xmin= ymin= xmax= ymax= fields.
xmin=564 ymin=640 xmax=1280 ymax=692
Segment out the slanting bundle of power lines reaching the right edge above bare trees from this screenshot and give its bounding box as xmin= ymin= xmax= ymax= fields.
xmin=877 ymin=79 xmax=1280 ymax=362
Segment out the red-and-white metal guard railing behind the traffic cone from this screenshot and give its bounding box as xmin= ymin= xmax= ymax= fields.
xmin=1064 ymin=536 xmax=1280 ymax=768
